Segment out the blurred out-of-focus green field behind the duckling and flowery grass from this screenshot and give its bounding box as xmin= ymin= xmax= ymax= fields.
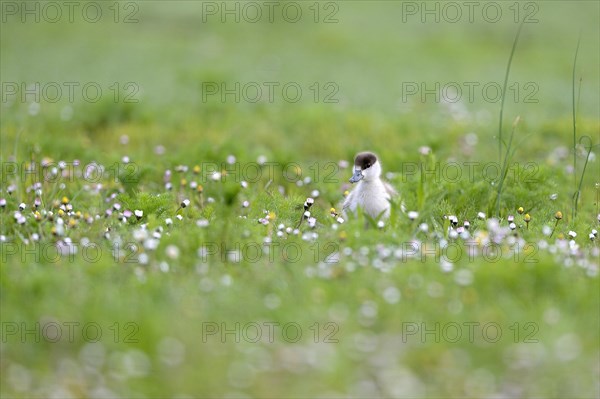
xmin=1 ymin=1 xmax=600 ymax=163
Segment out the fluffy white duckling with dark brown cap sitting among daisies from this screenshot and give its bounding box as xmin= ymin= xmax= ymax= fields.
xmin=342 ymin=152 xmax=398 ymax=219
